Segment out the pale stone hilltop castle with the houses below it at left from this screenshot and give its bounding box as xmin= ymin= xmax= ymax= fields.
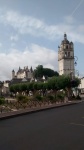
xmin=0 ymin=66 xmax=34 ymax=95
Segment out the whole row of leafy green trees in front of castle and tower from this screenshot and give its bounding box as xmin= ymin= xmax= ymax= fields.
xmin=10 ymin=75 xmax=80 ymax=100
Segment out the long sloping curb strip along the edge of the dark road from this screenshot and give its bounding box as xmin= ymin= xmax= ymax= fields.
xmin=0 ymin=101 xmax=82 ymax=120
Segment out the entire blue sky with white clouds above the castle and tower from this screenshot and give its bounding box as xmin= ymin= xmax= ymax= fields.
xmin=0 ymin=0 xmax=84 ymax=81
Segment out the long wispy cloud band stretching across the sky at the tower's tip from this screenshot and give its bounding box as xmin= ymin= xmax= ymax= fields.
xmin=0 ymin=11 xmax=84 ymax=44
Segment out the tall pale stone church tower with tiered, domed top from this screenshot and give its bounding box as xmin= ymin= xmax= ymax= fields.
xmin=58 ymin=33 xmax=75 ymax=75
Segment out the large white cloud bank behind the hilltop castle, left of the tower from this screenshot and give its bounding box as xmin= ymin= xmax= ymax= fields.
xmin=0 ymin=44 xmax=58 ymax=80
